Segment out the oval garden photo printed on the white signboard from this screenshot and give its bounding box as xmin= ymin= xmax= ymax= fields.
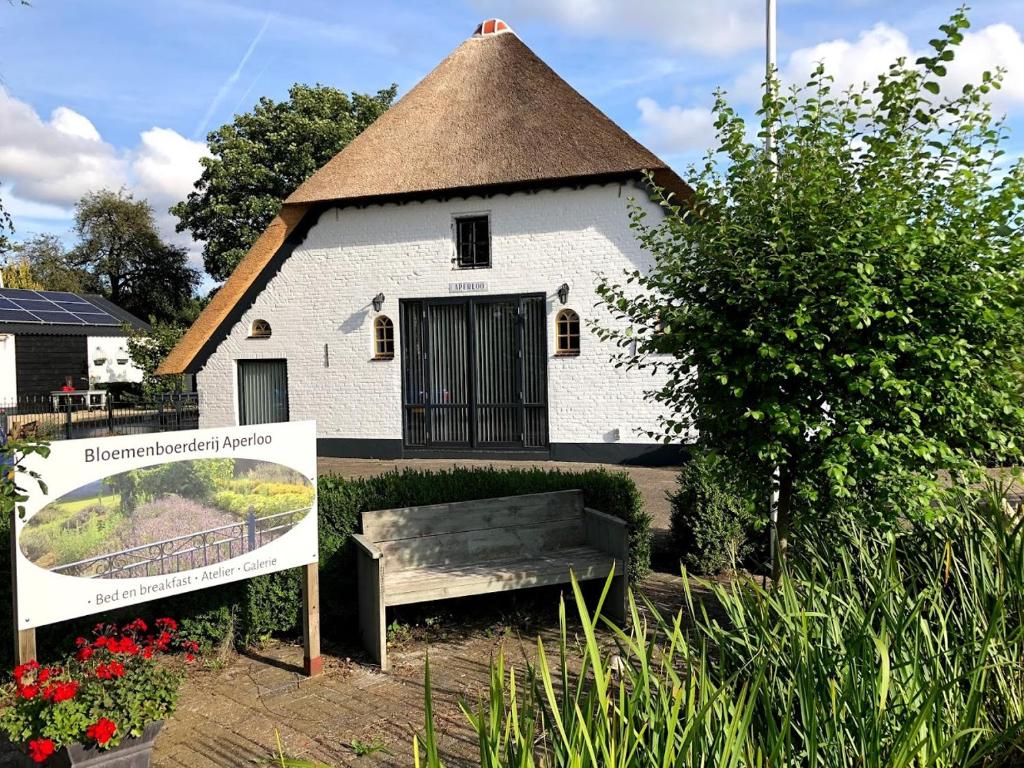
xmin=20 ymin=459 xmax=314 ymax=579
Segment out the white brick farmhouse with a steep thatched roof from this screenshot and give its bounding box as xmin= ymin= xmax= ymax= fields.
xmin=164 ymin=22 xmax=686 ymax=462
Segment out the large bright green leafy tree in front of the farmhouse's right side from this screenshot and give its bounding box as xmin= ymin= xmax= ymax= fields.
xmin=598 ymin=11 xmax=1024 ymax=573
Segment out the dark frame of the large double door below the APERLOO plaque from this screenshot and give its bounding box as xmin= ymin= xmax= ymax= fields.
xmin=398 ymin=291 xmax=551 ymax=455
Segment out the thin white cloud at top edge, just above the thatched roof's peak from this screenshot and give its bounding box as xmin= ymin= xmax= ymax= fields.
xmin=474 ymin=0 xmax=764 ymax=54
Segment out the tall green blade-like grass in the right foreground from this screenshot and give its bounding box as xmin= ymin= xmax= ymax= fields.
xmin=414 ymin=487 xmax=1024 ymax=768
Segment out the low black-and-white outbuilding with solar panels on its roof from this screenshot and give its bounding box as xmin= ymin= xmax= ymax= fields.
xmin=0 ymin=288 xmax=150 ymax=408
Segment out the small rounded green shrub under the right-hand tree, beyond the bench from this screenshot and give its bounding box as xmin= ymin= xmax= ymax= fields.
xmin=669 ymin=453 xmax=767 ymax=574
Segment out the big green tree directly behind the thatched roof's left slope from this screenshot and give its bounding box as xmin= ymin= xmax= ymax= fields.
xmin=171 ymin=83 xmax=397 ymax=281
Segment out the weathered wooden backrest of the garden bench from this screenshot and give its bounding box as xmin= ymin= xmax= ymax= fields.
xmin=362 ymin=490 xmax=586 ymax=568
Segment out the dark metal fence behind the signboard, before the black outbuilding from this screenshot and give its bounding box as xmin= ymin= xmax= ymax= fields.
xmin=0 ymin=392 xmax=199 ymax=440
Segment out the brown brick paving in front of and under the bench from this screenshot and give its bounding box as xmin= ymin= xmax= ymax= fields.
xmin=154 ymin=573 xmax=682 ymax=768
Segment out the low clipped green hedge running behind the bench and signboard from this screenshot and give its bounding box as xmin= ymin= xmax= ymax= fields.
xmin=0 ymin=467 xmax=650 ymax=657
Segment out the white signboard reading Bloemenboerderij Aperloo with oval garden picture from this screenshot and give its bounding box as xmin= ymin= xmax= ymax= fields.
xmin=14 ymin=422 xmax=317 ymax=630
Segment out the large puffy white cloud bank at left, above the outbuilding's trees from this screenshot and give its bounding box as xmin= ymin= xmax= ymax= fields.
xmin=0 ymin=87 xmax=208 ymax=265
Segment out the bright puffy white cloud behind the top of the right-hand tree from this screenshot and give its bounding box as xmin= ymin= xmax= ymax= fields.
xmin=731 ymin=24 xmax=1024 ymax=110
